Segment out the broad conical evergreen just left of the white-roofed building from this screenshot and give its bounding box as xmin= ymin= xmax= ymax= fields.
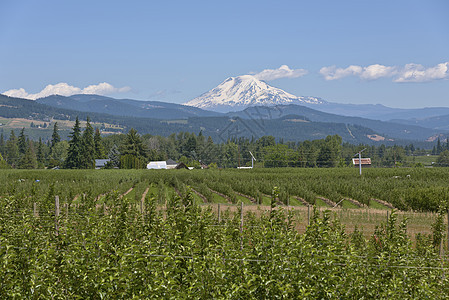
xmin=120 ymin=128 xmax=147 ymax=169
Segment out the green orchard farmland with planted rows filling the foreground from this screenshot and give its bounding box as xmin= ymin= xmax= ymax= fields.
xmin=0 ymin=168 xmax=449 ymax=299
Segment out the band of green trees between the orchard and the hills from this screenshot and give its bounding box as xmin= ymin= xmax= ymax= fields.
xmin=0 ymin=118 xmax=449 ymax=169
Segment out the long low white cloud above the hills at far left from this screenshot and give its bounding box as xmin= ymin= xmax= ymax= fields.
xmin=3 ymin=82 xmax=130 ymax=100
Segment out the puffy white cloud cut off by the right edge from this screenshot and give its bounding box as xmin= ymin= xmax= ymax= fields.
xmin=394 ymin=62 xmax=449 ymax=82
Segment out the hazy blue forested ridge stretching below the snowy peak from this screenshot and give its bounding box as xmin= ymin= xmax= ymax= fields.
xmin=0 ymin=95 xmax=446 ymax=144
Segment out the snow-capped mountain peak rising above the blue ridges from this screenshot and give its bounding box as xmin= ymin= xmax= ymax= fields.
xmin=184 ymin=75 xmax=325 ymax=112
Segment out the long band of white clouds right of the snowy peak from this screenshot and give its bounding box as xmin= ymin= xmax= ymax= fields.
xmin=320 ymin=62 xmax=449 ymax=82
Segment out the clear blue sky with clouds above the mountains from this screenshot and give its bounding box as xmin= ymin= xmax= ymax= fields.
xmin=0 ymin=0 xmax=449 ymax=108
